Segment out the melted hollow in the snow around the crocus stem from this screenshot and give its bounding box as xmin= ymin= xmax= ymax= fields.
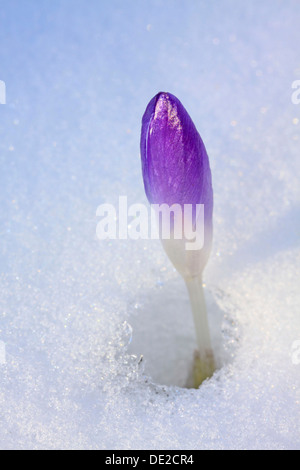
xmin=128 ymin=278 xmax=237 ymax=387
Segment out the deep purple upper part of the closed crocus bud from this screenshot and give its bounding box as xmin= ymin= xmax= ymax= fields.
xmin=141 ymin=92 xmax=213 ymax=225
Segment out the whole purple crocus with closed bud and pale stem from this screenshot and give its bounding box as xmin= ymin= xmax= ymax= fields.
xmin=141 ymin=92 xmax=214 ymax=382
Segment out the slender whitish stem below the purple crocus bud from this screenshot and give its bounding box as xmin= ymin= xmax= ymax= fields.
xmin=185 ymin=276 xmax=216 ymax=388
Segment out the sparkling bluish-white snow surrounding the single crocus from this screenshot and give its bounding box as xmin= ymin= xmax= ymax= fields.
xmin=0 ymin=0 xmax=300 ymax=449
